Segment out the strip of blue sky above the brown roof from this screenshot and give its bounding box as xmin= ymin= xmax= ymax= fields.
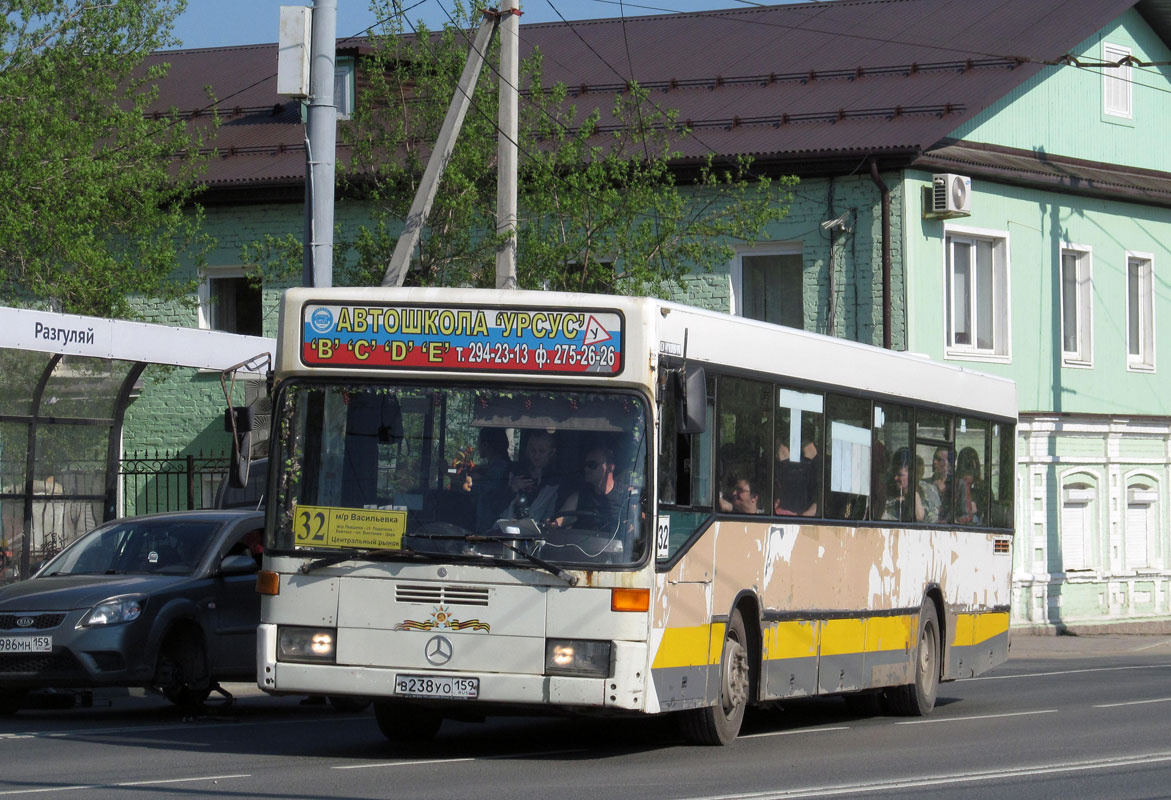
xmin=174 ymin=0 xmax=758 ymax=48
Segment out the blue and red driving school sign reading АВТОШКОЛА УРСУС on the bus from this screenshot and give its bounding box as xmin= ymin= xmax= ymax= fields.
xmin=301 ymin=303 xmax=624 ymax=375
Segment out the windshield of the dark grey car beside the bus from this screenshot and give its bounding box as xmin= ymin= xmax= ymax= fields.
xmin=41 ymin=519 xmax=222 ymax=576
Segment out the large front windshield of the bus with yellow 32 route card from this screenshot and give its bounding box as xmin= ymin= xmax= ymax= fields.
xmin=268 ymin=381 xmax=649 ymax=568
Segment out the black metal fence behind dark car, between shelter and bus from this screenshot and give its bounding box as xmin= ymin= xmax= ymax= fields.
xmin=118 ymin=451 xmax=230 ymax=517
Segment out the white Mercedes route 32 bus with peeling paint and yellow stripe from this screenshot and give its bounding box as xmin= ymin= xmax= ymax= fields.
xmin=258 ymin=288 xmax=1016 ymax=744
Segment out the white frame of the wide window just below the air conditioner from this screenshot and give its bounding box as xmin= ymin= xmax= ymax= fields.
xmin=941 ymin=225 xmax=1013 ymax=363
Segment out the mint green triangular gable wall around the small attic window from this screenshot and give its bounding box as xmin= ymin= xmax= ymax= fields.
xmin=952 ymin=9 xmax=1171 ymax=170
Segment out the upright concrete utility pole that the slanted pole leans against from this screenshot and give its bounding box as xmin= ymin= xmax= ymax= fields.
xmin=497 ymin=0 xmax=520 ymax=289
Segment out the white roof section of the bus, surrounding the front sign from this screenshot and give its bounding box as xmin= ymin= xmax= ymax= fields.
xmin=276 ymin=287 xmax=1016 ymax=418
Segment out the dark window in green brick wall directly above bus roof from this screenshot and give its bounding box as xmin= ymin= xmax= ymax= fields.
xmin=732 ymin=244 xmax=804 ymax=328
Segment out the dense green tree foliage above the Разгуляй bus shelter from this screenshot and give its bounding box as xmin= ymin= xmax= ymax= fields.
xmin=0 ymin=0 xmax=206 ymax=316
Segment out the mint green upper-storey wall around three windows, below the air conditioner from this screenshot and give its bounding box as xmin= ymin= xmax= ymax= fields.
xmin=904 ymin=172 xmax=1171 ymax=415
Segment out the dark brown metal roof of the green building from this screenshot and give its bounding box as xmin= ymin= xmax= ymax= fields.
xmin=144 ymin=0 xmax=1142 ymax=199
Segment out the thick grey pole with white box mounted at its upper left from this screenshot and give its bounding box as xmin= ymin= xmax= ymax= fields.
xmin=306 ymin=0 xmax=337 ymax=287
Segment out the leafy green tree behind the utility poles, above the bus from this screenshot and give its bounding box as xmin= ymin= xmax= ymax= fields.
xmin=306 ymin=2 xmax=792 ymax=295
